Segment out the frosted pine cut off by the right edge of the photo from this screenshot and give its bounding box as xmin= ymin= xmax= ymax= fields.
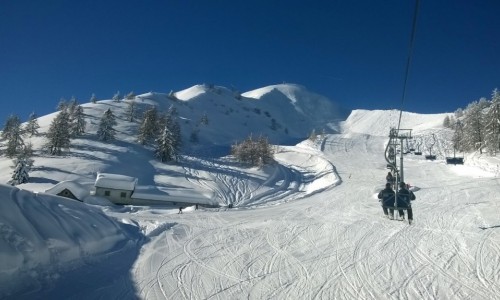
xmin=484 ymin=89 xmax=500 ymax=155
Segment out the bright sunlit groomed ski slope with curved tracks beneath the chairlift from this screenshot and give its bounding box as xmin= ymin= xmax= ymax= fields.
xmin=75 ymin=134 xmax=500 ymax=299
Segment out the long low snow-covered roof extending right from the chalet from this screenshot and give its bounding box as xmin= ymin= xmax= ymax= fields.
xmin=132 ymin=186 xmax=215 ymax=205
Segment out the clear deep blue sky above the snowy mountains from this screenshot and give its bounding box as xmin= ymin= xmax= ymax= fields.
xmin=0 ymin=0 xmax=500 ymax=126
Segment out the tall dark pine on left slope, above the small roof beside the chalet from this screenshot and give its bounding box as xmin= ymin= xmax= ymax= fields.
xmin=44 ymin=110 xmax=71 ymax=155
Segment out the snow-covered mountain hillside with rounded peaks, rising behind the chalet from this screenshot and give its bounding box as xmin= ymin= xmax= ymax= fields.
xmin=0 ymin=84 xmax=342 ymax=191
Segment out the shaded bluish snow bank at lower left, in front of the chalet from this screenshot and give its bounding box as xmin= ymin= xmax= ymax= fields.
xmin=0 ymin=185 xmax=139 ymax=298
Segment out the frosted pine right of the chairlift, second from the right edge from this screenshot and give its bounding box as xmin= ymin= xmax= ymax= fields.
xmin=463 ymin=101 xmax=484 ymax=153
